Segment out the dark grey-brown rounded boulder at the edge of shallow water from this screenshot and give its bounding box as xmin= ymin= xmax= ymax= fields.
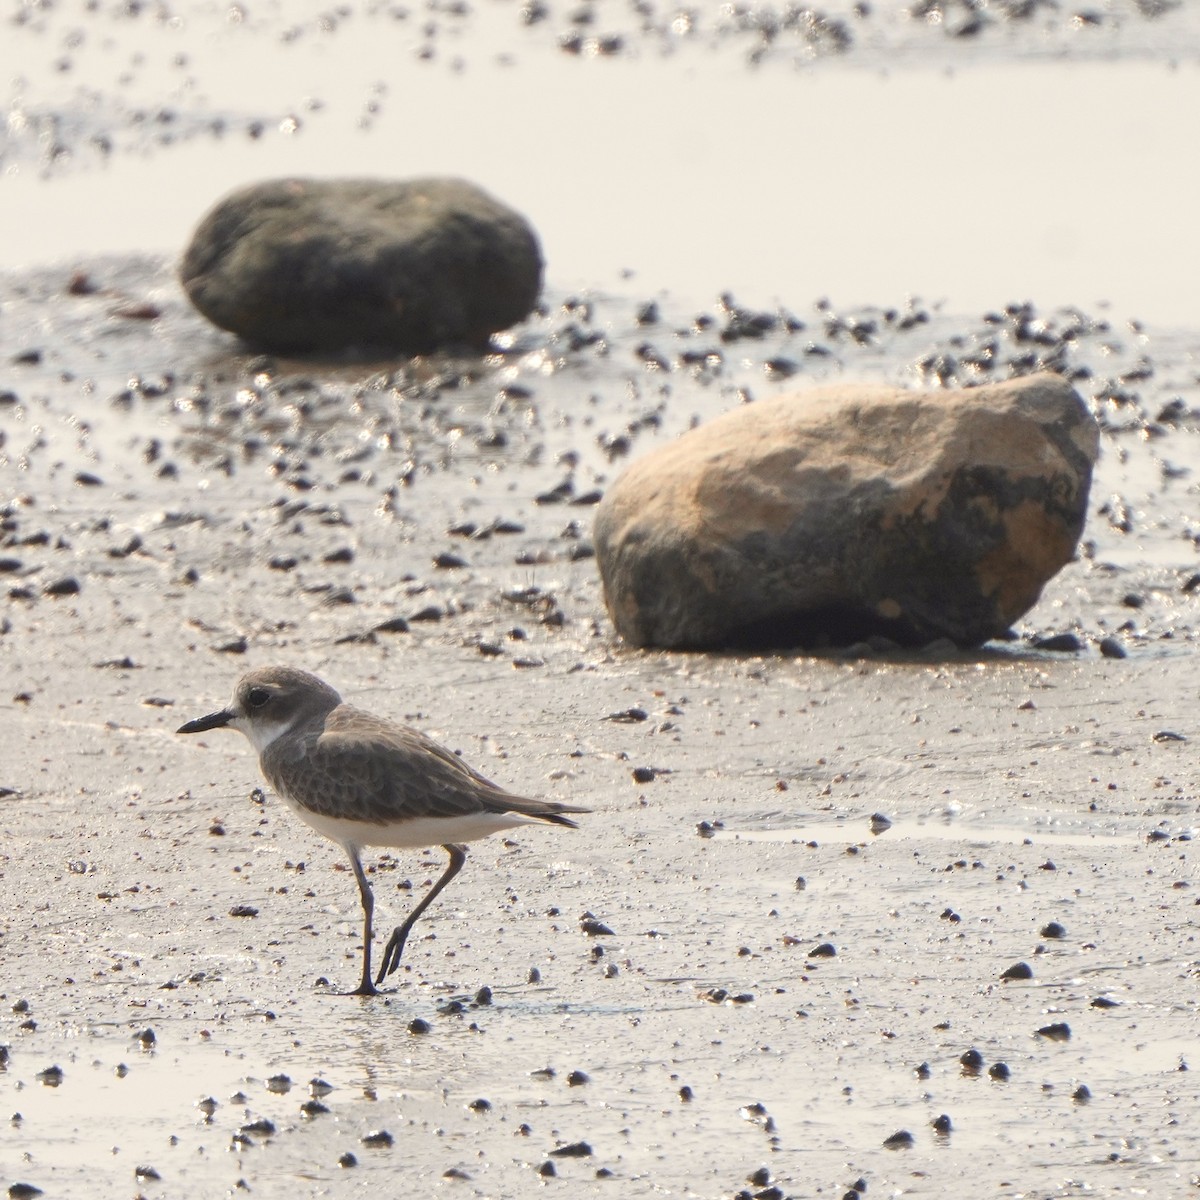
xmin=180 ymin=179 xmax=542 ymax=353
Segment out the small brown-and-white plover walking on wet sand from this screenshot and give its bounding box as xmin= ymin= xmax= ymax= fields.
xmin=178 ymin=667 xmax=588 ymax=996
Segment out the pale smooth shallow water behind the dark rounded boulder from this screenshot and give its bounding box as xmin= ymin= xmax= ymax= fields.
xmin=7 ymin=5 xmax=1200 ymax=328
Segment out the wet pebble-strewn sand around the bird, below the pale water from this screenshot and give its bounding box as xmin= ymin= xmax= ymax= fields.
xmin=0 ymin=4 xmax=1200 ymax=1200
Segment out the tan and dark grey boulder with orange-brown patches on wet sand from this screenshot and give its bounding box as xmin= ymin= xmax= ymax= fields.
xmin=595 ymin=374 xmax=1099 ymax=648
